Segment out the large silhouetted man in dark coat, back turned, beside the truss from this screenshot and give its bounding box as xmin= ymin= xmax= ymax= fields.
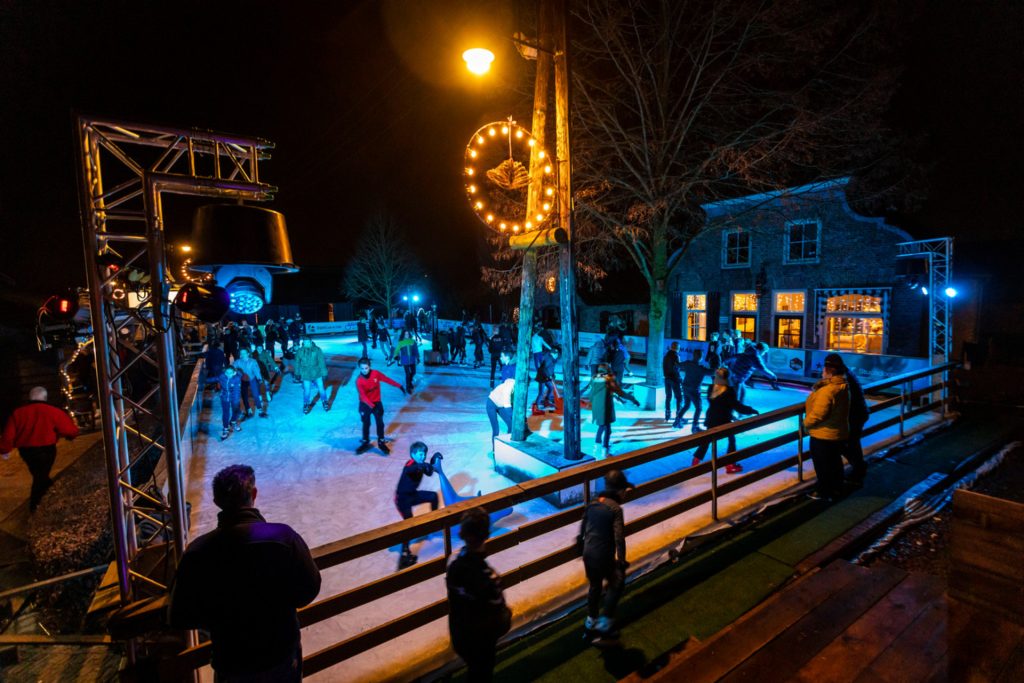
xmin=168 ymin=465 xmax=321 ymax=683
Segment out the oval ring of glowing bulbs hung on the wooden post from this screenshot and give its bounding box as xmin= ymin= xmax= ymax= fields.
xmin=463 ymin=120 xmax=555 ymax=233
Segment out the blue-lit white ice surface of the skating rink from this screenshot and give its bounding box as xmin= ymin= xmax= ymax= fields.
xmin=187 ymin=337 xmax=942 ymax=681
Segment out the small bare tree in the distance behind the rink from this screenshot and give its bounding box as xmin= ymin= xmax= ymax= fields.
xmin=345 ymin=211 xmax=416 ymax=315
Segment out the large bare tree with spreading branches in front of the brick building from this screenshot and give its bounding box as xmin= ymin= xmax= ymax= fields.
xmin=572 ymin=0 xmax=909 ymax=395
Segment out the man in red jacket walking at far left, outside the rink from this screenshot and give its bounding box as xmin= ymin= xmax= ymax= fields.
xmin=0 ymin=387 xmax=78 ymax=512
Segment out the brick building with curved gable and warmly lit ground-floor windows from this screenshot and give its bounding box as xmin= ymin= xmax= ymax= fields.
xmin=668 ymin=178 xmax=928 ymax=356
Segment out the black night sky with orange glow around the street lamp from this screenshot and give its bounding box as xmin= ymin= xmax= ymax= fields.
xmin=0 ymin=0 xmax=1024 ymax=309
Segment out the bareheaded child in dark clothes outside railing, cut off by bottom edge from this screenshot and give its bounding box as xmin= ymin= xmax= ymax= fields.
xmin=444 ymin=508 xmax=512 ymax=683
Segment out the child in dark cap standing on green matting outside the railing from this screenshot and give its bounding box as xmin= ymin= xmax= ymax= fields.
xmin=577 ymin=470 xmax=635 ymax=634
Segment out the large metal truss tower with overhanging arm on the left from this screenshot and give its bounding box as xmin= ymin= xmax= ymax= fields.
xmin=75 ymin=116 xmax=275 ymax=604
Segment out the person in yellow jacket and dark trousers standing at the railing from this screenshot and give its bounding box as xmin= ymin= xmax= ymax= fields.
xmin=804 ymin=359 xmax=850 ymax=501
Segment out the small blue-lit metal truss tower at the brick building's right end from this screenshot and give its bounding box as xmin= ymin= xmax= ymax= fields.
xmin=896 ymin=238 xmax=953 ymax=366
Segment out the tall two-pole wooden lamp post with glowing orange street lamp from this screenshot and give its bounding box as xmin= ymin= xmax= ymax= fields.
xmin=463 ymin=0 xmax=583 ymax=460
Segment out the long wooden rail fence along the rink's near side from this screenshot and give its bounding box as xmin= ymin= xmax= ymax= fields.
xmin=168 ymin=364 xmax=956 ymax=676
